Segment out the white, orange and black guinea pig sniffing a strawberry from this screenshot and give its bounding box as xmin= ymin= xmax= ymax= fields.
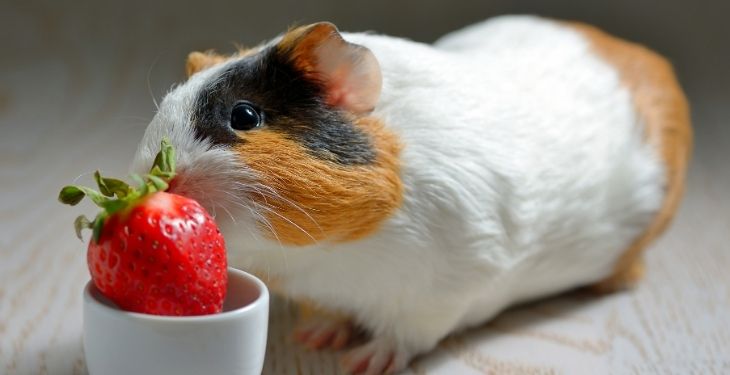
xmin=133 ymin=16 xmax=692 ymax=374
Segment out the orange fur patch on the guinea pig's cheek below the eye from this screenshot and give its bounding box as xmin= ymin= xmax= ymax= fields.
xmin=237 ymin=117 xmax=403 ymax=246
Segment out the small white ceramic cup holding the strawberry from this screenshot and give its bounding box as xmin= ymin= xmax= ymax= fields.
xmin=84 ymin=268 xmax=269 ymax=375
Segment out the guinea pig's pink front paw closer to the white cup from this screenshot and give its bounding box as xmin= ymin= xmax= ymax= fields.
xmin=294 ymin=316 xmax=355 ymax=350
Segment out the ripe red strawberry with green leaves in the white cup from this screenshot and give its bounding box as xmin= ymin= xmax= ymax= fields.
xmin=59 ymin=140 xmax=227 ymax=315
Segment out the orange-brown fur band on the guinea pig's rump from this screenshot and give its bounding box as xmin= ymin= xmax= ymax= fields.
xmin=568 ymin=23 xmax=692 ymax=291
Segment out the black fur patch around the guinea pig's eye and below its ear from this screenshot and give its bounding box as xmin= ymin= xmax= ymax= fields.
xmin=192 ymin=46 xmax=375 ymax=165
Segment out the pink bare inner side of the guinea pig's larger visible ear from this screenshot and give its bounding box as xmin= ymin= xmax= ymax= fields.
xmin=316 ymin=38 xmax=382 ymax=114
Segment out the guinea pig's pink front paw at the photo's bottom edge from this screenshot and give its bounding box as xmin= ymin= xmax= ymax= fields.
xmin=341 ymin=337 xmax=412 ymax=375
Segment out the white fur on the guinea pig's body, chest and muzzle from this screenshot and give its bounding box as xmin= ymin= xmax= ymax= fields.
xmin=132 ymin=16 xmax=663 ymax=368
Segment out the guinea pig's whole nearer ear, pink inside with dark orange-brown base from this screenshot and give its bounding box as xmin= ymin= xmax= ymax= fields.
xmin=277 ymin=22 xmax=382 ymax=114
